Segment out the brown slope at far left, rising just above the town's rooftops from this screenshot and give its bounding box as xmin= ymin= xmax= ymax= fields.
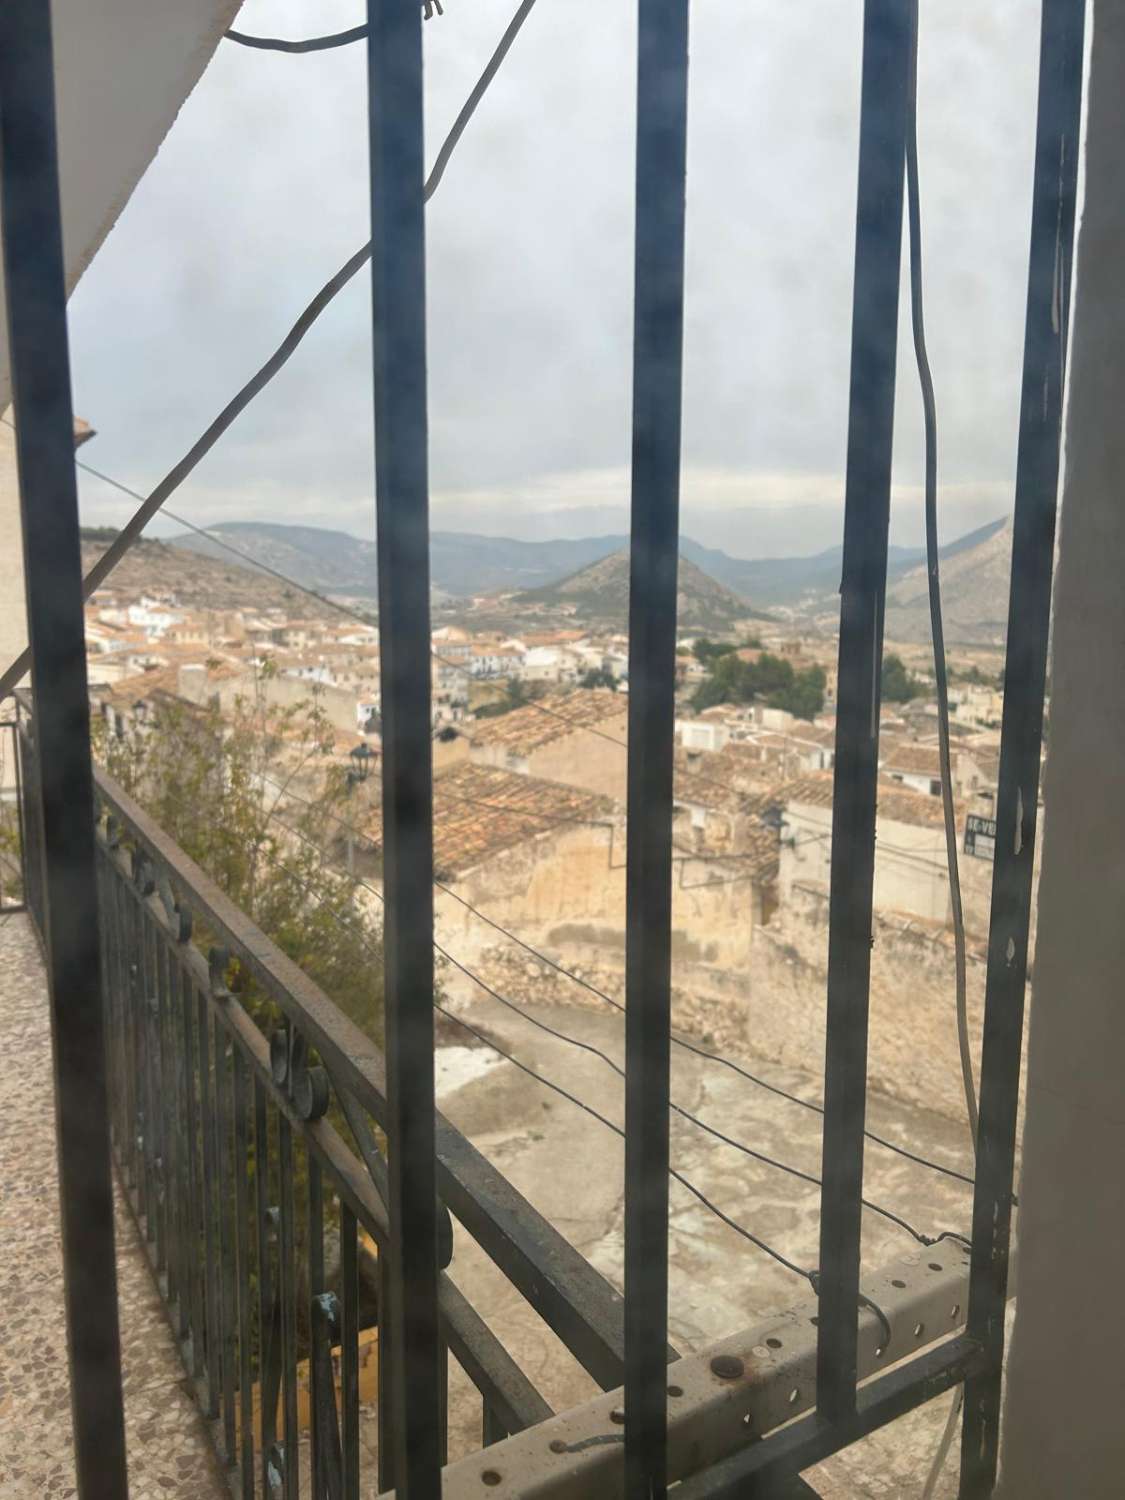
xmin=83 ymin=533 xmax=338 ymax=620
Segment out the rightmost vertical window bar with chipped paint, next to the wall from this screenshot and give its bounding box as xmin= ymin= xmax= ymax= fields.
xmin=960 ymin=0 xmax=1086 ymax=1500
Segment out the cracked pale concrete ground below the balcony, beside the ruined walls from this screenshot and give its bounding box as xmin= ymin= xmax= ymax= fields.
xmin=441 ymin=992 xmax=972 ymax=1500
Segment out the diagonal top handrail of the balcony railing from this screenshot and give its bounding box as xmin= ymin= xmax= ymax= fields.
xmin=96 ymin=771 xmax=636 ymax=1389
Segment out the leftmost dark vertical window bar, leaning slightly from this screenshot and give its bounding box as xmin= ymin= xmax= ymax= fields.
xmin=0 ymin=0 xmax=128 ymax=1500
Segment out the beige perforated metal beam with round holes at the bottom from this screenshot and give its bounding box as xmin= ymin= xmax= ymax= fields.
xmin=381 ymin=1244 xmax=977 ymax=1500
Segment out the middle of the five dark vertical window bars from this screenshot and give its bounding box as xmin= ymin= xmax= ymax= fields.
xmin=626 ymin=0 xmax=689 ymax=1500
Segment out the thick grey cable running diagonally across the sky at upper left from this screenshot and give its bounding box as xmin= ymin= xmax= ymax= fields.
xmin=0 ymin=0 xmax=536 ymax=701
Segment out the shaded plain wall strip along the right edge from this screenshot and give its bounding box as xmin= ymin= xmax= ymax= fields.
xmin=998 ymin=0 xmax=1125 ymax=1500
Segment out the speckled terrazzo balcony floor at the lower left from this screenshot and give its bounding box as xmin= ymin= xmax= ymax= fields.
xmin=0 ymin=915 xmax=230 ymax=1500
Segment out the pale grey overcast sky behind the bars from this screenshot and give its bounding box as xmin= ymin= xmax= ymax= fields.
xmin=63 ymin=0 xmax=1040 ymax=557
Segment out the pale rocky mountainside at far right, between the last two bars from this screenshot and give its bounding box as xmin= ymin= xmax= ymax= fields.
xmin=887 ymin=519 xmax=1011 ymax=645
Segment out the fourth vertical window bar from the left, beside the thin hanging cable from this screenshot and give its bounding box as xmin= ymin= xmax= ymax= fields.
xmin=818 ymin=0 xmax=911 ymax=1421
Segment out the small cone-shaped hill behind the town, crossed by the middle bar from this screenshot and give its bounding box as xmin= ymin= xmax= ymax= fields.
xmin=512 ymin=549 xmax=762 ymax=630
